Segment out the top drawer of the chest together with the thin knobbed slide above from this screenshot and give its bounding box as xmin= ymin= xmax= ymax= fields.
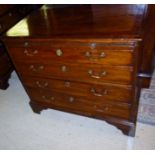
xmin=9 ymin=41 xmax=134 ymax=66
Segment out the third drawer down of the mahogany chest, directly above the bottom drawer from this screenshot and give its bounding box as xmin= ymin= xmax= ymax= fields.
xmin=22 ymin=77 xmax=132 ymax=103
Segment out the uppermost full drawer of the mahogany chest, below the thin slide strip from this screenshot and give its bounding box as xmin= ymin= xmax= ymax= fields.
xmin=9 ymin=45 xmax=133 ymax=66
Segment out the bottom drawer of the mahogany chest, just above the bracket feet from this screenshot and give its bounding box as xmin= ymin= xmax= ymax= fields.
xmin=27 ymin=88 xmax=130 ymax=120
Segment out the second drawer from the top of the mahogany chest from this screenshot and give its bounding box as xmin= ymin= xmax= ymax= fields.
xmin=16 ymin=62 xmax=133 ymax=85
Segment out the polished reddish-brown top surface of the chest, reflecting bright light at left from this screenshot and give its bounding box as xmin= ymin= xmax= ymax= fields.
xmin=5 ymin=5 xmax=147 ymax=39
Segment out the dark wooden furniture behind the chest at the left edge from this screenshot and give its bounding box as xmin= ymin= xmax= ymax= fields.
xmin=0 ymin=4 xmax=40 ymax=89
